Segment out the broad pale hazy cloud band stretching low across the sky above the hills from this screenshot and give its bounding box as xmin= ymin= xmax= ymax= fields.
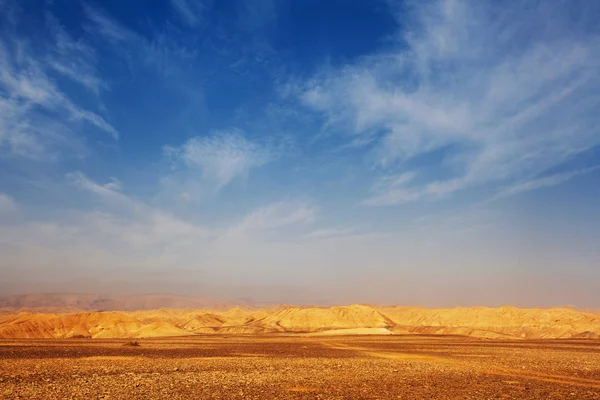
xmin=0 ymin=173 xmax=597 ymax=303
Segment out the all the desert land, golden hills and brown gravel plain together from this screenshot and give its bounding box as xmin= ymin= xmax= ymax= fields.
xmin=0 ymin=298 xmax=600 ymax=399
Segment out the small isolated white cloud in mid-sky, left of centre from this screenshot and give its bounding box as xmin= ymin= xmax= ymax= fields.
xmin=165 ymin=130 xmax=277 ymax=189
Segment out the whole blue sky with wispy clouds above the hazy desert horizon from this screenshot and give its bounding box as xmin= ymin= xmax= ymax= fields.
xmin=0 ymin=0 xmax=600 ymax=307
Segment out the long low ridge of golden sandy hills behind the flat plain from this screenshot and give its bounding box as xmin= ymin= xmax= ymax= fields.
xmin=0 ymin=305 xmax=600 ymax=339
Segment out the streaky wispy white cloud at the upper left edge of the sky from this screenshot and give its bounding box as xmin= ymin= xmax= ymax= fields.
xmin=0 ymin=6 xmax=118 ymax=160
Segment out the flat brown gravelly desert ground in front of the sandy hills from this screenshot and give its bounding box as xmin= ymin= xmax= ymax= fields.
xmin=0 ymin=334 xmax=600 ymax=399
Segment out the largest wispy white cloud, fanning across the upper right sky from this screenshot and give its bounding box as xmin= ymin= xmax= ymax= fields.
xmin=298 ymin=0 xmax=600 ymax=205
